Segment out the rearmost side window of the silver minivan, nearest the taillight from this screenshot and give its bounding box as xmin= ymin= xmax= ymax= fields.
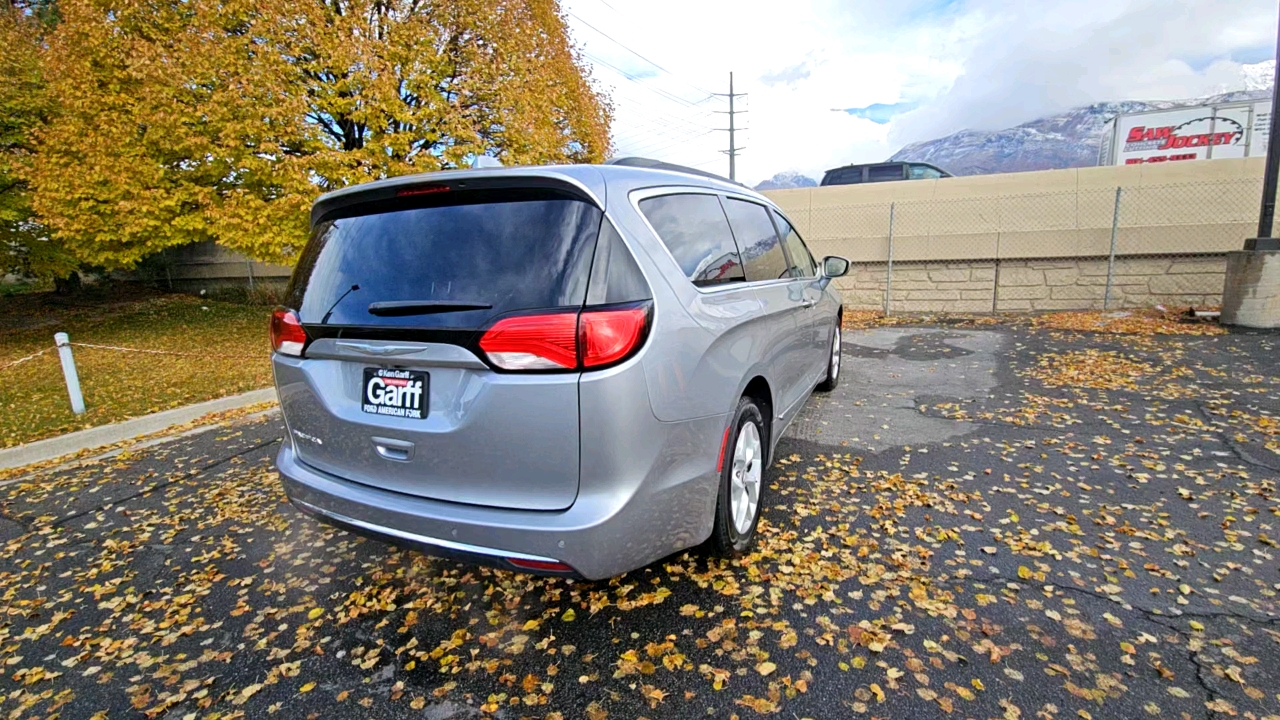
xmin=640 ymin=193 xmax=746 ymax=287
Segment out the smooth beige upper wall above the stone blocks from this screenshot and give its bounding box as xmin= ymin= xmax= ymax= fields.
xmin=765 ymin=158 xmax=1262 ymax=263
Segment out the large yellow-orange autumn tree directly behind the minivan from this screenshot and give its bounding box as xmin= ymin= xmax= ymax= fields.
xmin=32 ymin=0 xmax=609 ymax=268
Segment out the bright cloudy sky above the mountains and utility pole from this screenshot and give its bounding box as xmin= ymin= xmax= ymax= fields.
xmin=562 ymin=0 xmax=1276 ymax=184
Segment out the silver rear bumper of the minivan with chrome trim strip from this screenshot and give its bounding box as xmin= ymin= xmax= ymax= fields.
xmin=276 ymin=409 xmax=726 ymax=579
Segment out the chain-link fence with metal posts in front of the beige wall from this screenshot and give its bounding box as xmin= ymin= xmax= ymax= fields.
xmin=783 ymin=176 xmax=1262 ymax=313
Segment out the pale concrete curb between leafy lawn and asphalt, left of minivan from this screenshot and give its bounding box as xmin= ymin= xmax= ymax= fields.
xmin=0 ymin=388 xmax=275 ymax=470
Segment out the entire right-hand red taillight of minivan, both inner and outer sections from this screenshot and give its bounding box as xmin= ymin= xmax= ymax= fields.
xmin=480 ymin=305 xmax=649 ymax=370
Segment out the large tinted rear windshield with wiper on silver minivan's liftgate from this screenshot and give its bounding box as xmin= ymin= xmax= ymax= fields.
xmin=289 ymin=190 xmax=603 ymax=328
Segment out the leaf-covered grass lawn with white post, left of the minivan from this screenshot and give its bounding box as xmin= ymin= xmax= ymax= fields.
xmin=0 ymin=292 xmax=271 ymax=447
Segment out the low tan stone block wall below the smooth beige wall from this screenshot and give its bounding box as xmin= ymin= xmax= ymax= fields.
xmin=836 ymin=255 xmax=1226 ymax=313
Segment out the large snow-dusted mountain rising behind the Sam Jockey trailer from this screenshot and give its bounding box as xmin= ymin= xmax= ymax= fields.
xmin=890 ymin=60 xmax=1275 ymax=176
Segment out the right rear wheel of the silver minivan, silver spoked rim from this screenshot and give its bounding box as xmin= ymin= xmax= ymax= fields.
xmin=710 ymin=397 xmax=769 ymax=557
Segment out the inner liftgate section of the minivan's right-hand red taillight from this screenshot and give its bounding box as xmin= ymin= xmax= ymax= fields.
xmin=480 ymin=313 xmax=577 ymax=370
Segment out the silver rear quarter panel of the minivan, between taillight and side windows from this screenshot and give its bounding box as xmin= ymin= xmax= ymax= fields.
xmin=608 ymin=188 xmax=774 ymax=421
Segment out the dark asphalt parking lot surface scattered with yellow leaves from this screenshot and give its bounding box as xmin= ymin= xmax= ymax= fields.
xmin=0 ymin=327 xmax=1280 ymax=720
